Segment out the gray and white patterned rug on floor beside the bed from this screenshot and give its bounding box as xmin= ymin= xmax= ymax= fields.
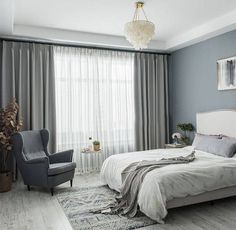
xmin=57 ymin=186 xmax=155 ymax=230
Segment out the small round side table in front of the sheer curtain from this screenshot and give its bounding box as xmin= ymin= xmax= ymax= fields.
xmin=80 ymin=150 xmax=105 ymax=173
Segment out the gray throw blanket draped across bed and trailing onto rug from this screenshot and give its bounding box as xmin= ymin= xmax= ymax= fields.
xmin=93 ymin=151 xmax=195 ymax=217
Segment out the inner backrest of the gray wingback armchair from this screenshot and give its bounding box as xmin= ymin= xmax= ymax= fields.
xmin=20 ymin=130 xmax=48 ymax=160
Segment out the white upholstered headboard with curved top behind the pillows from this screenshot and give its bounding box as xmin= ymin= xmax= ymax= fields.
xmin=196 ymin=110 xmax=236 ymax=138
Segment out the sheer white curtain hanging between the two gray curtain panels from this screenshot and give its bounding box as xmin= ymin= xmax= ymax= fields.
xmin=54 ymin=46 xmax=134 ymax=170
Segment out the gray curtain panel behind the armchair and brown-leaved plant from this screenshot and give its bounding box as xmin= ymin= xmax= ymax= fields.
xmin=0 ymin=41 xmax=56 ymax=152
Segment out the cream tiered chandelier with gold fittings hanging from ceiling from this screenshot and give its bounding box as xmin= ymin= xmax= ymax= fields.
xmin=124 ymin=2 xmax=155 ymax=50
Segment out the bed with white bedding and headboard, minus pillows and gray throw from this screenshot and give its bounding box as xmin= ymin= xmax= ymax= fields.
xmin=101 ymin=110 xmax=236 ymax=223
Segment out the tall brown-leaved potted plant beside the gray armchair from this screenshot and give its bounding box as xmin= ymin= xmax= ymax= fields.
xmin=0 ymin=98 xmax=23 ymax=192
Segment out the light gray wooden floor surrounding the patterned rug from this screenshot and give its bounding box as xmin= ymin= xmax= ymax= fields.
xmin=0 ymin=174 xmax=236 ymax=230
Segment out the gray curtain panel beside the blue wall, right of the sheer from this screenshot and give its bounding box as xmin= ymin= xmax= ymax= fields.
xmin=134 ymin=53 xmax=169 ymax=150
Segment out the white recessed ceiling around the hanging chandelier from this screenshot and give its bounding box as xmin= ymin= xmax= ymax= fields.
xmin=0 ymin=0 xmax=236 ymax=49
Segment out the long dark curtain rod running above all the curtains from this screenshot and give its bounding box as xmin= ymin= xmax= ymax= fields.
xmin=0 ymin=36 xmax=171 ymax=56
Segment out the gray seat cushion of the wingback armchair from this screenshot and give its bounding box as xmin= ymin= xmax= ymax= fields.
xmin=48 ymin=162 xmax=76 ymax=176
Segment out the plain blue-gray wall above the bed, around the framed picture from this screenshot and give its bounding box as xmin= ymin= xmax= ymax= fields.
xmin=169 ymin=30 xmax=236 ymax=135
